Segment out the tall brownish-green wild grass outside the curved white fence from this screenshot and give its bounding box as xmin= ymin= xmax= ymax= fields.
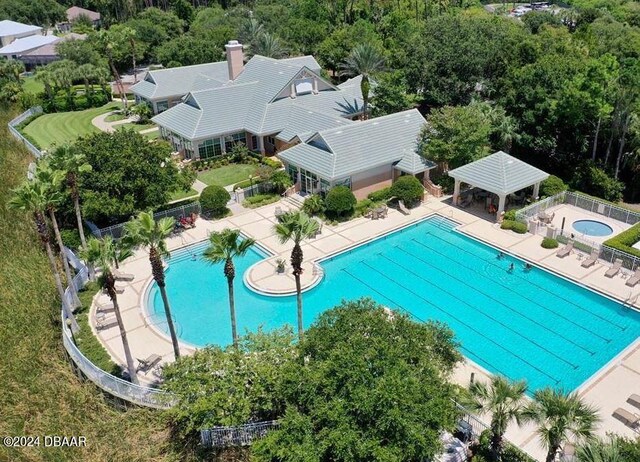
xmin=0 ymin=108 xmax=204 ymax=462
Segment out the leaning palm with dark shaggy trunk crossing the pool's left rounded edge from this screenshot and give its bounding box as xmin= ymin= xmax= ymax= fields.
xmin=124 ymin=212 xmax=180 ymax=359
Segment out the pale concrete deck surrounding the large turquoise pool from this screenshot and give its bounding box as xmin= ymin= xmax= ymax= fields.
xmin=91 ymin=197 xmax=640 ymax=459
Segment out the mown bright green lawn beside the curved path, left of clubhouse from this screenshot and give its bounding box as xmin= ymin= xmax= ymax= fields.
xmin=22 ymin=102 xmax=120 ymax=149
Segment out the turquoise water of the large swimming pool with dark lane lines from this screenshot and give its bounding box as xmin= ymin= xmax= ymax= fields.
xmin=149 ymin=217 xmax=640 ymax=390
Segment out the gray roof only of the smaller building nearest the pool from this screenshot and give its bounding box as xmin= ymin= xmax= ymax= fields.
xmin=278 ymin=109 xmax=435 ymax=180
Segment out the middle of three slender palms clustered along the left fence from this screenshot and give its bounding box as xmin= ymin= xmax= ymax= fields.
xmin=35 ymin=162 xmax=81 ymax=307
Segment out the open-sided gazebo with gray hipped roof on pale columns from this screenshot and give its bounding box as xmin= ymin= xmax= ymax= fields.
xmin=448 ymin=151 xmax=549 ymax=217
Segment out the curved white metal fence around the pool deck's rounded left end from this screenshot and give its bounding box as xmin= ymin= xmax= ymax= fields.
xmin=61 ymin=248 xmax=175 ymax=409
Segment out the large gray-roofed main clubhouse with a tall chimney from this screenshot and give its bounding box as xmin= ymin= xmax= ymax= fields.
xmin=146 ymin=41 xmax=362 ymax=159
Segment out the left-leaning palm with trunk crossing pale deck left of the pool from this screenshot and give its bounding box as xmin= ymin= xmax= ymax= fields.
xmin=80 ymin=236 xmax=138 ymax=385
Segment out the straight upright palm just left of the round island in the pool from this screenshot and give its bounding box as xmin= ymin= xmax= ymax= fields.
xmin=203 ymin=229 xmax=255 ymax=348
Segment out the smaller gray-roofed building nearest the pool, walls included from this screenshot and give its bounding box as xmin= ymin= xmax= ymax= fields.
xmin=278 ymin=109 xmax=436 ymax=199
